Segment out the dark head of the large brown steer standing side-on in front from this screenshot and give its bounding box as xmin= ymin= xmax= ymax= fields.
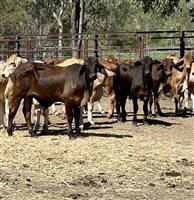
xmin=80 ymin=57 xmax=104 ymax=82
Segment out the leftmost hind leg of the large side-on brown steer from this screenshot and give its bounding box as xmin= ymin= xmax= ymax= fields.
xmin=7 ymin=97 xmax=22 ymax=136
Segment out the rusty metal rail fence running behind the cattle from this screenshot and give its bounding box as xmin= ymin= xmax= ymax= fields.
xmin=0 ymin=30 xmax=194 ymax=60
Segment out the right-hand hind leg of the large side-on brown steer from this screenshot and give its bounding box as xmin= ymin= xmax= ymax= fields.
xmin=22 ymin=96 xmax=33 ymax=136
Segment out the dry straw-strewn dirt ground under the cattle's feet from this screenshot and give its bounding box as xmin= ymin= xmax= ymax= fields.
xmin=0 ymin=97 xmax=194 ymax=200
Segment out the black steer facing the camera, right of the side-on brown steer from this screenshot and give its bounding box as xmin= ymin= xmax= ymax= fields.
xmin=114 ymin=61 xmax=151 ymax=126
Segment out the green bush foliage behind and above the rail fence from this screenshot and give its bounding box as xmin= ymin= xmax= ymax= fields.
xmin=0 ymin=0 xmax=194 ymax=59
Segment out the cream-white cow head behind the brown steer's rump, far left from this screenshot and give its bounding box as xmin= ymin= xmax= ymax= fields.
xmin=1 ymin=54 xmax=27 ymax=78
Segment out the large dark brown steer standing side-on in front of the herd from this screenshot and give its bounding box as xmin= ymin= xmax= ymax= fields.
xmin=5 ymin=57 xmax=102 ymax=139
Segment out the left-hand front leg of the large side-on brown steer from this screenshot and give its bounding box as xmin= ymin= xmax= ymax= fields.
xmin=65 ymin=103 xmax=75 ymax=139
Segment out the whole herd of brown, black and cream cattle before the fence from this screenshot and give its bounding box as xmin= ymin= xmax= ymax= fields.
xmin=0 ymin=54 xmax=194 ymax=139
